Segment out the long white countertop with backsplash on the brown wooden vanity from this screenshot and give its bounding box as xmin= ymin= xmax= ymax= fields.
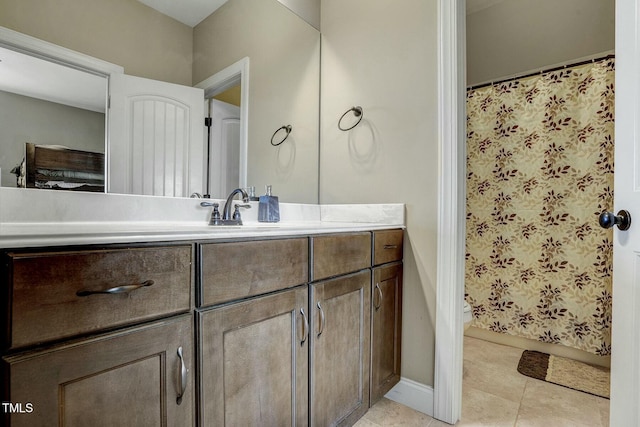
xmin=0 ymin=190 xmax=405 ymax=249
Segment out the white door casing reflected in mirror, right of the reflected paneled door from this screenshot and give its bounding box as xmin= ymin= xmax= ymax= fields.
xmin=194 ymin=56 xmax=249 ymax=191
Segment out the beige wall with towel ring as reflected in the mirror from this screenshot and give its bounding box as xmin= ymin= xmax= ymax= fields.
xmin=193 ymin=0 xmax=320 ymax=203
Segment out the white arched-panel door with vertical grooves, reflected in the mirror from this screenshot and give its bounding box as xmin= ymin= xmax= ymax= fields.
xmin=107 ymin=74 xmax=206 ymax=197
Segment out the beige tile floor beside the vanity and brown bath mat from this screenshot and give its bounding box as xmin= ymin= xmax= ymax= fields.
xmin=356 ymin=337 xmax=609 ymax=427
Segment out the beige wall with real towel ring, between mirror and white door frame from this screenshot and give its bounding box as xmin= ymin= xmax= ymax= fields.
xmin=320 ymin=0 xmax=438 ymax=385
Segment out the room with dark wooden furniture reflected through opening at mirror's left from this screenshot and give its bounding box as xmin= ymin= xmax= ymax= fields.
xmin=0 ymin=47 xmax=107 ymax=192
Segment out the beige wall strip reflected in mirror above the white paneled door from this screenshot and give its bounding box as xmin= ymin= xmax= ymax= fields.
xmin=0 ymin=0 xmax=193 ymax=86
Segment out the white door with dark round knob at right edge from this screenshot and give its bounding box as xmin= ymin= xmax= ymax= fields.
xmin=610 ymin=0 xmax=640 ymax=426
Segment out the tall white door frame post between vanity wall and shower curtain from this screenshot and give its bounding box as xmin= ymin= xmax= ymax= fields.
xmin=433 ymin=0 xmax=466 ymax=424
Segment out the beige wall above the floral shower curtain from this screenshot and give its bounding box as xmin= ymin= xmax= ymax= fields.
xmin=467 ymin=0 xmax=615 ymax=85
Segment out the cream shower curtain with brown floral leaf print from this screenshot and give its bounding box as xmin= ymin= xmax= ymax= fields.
xmin=465 ymin=58 xmax=614 ymax=355
